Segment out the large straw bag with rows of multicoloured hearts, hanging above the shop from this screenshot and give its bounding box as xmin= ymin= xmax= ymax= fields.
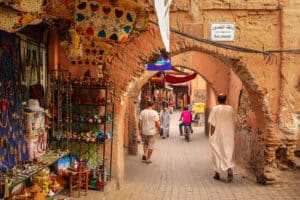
xmin=75 ymin=0 xmax=136 ymax=42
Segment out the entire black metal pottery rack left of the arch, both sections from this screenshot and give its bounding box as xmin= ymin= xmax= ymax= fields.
xmin=49 ymin=70 xmax=114 ymax=190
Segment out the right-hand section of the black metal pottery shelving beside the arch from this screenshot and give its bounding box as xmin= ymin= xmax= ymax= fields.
xmin=70 ymin=85 xmax=114 ymax=189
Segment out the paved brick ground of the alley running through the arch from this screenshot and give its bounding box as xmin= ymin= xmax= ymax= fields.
xmin=56 ymin=112 xmax=300 ymax=200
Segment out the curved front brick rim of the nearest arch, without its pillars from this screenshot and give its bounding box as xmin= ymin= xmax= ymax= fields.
xmin=105 ymin=24 xmax=268 ymax=121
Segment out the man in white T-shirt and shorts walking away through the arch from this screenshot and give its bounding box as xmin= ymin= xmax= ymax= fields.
xmin=139 ymin=101 xmax=160 ymax=164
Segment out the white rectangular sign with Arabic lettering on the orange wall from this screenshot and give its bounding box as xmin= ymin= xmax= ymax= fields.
xmin=210 ymin=23 xmax=235 ymax=41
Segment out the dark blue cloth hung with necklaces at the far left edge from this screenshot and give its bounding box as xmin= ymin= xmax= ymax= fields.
xmin=0 ymin=31 xmax=28 ymax=170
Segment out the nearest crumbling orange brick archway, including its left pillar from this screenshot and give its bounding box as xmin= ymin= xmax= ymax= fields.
xmin=106 ymin=25 xmax=278 ymax=184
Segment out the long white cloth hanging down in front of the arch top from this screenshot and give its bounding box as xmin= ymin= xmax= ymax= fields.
xmin=154 ymin=0 xmax=172 ymax=52
